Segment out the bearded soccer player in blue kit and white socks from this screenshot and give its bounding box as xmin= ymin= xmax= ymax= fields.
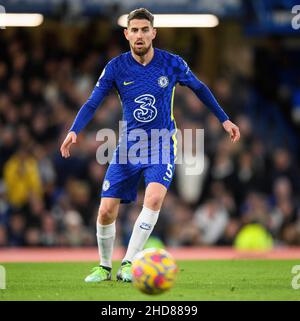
xmin=60 ymin=8 xmax=240 ymax=282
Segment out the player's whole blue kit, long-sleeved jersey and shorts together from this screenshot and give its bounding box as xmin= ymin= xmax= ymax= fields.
xmin=70 ymin=48 xmax=228 ymax=202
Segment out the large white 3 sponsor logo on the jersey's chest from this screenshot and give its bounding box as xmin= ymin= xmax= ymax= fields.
xmin=133 ymin=94 xmax=157 ymax=123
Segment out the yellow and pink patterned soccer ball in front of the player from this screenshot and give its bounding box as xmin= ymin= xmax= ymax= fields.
xmin=132 ymin=248 xmax=178 ymax=294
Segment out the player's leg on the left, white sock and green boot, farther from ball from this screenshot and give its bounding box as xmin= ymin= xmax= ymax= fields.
xmin=85 ymin=197 xmax=121 ymax=282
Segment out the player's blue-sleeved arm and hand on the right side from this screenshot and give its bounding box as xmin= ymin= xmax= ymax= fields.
xmin=178 ymin=58 xmax=240 ymax=142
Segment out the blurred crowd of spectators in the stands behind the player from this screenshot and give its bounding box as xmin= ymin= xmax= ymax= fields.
xmin=0 ymin=23 xmax=300 ymax=246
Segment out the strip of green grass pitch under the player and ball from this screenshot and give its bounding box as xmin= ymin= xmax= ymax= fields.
xmin=0 ymin=260 xmax=300 ymax=301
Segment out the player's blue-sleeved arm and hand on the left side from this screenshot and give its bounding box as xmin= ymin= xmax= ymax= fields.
xmin=60 ymin=61 xmax=114 ymax=158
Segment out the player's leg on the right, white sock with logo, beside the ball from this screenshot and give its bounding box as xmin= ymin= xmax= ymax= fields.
xmin=117 ymin=182 xmax=167 ymax=282
